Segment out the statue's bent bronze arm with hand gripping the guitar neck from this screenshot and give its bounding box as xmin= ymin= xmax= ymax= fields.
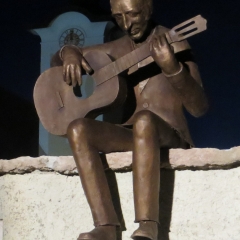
xmin=151 ymin=35 xmax=208 ymax=117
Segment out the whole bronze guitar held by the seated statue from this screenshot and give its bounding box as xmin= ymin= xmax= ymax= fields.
xmin=33 ymin=15 xmax=207 ymax=135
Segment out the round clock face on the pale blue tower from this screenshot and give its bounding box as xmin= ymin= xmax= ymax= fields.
xmin=59 ymin=28 xmax=85 ymax=47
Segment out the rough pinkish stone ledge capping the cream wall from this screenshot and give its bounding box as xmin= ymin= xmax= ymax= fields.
xmin=0 ymin=146 xmax=240 ymax=175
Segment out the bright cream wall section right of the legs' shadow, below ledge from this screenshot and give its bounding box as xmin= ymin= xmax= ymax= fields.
xmin=170 ymin=168 xmax=240 ymax=240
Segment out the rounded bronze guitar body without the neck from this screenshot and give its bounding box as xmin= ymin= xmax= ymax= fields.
xmin=33 ymin=51 xmax=127 ymax=135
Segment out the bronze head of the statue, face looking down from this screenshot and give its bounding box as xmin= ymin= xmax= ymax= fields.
xmin=110 ymin=0 xmax=152 ymax=41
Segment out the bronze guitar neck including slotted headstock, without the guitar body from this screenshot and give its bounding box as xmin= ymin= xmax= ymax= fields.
xmin=94 ymin=15 xmax=207 ymax=84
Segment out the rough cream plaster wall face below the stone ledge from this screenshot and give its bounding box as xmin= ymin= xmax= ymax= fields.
xmin=0 ymin=168 xmax=240 ymax=240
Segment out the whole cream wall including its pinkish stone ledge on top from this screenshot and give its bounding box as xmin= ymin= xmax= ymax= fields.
xmin=0 ymin=147 xmax=240 ymax=240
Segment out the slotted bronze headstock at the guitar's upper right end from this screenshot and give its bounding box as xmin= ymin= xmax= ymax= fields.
xmin=166 ymin=15 xmax=207 ymax=44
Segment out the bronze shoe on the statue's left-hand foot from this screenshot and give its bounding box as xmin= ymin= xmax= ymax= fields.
xmin=77 ymin=226 xmax=117 ymax=240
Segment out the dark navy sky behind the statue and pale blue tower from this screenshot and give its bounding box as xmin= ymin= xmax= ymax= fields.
xmin=0 ymin=0 xmax=240 ymax=154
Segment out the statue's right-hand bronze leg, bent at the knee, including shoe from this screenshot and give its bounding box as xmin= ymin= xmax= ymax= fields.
xmin=132 ymin=110 xmax=188 ymax=240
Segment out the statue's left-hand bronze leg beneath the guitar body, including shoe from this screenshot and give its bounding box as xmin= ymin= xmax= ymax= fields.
xmin=68 ymin=118 xmax=133 ymax=240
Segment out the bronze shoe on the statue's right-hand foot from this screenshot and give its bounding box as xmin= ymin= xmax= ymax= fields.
xmin=131 ymin=221 xmax=158 ymax=240
